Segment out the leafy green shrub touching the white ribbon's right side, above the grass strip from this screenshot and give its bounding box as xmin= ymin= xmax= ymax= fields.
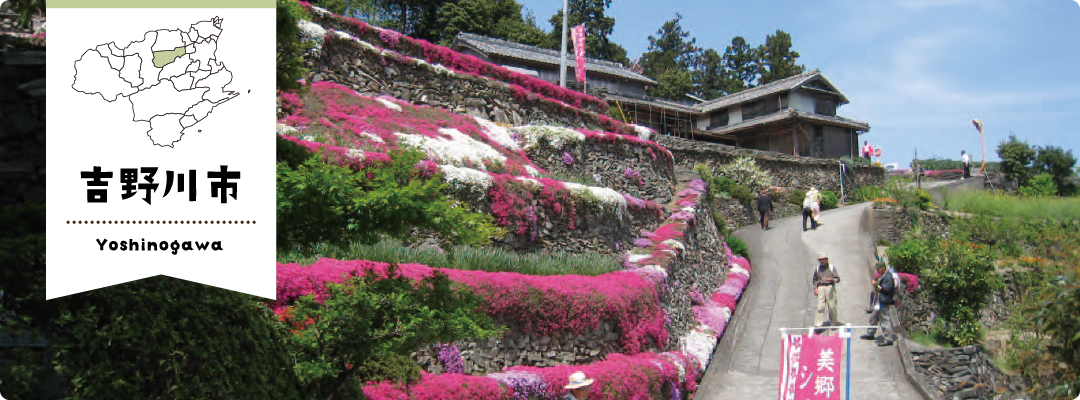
xmin=276 ymin=149 xmax=505 ymax=250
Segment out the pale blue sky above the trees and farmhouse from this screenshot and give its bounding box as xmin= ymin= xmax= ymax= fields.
xmin=518 ymin=0 xmax=1080 ymax=168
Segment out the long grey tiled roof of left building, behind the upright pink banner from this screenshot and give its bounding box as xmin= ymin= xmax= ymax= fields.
xmin=450 ymin=32 xmax=658 ymax=84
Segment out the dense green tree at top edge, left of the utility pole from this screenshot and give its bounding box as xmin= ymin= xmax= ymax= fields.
xmin=438 ymin=0 xmax=545 ymax=45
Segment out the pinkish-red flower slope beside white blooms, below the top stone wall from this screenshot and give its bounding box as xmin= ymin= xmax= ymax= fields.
xmin=278 ymin=81 xmax=543 ymax=175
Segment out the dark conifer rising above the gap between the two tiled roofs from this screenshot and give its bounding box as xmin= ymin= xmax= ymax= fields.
xmin=642 ymin=13 xmax=701 ymax=98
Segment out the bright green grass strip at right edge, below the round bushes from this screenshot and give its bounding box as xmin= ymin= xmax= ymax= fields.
xmin=947 ymin=190 xmax=1080 ymax=219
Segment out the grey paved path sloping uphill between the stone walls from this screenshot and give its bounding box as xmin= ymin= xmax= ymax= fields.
xmin=694 ymin=203 xmax=921 ymax=400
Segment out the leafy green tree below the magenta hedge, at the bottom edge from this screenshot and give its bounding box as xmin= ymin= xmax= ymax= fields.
xmin=285 ymin=265 xmax=502 ymax=399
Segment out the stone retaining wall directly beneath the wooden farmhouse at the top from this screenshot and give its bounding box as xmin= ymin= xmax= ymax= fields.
xmin=656 ymin=136 xmax=885 ymax=196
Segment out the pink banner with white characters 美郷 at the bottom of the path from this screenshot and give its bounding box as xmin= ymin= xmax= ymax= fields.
xmin=780 ymin=335 xmax=843 ymax=400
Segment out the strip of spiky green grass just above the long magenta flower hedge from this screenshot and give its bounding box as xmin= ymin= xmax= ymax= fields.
xmin=278 ymin=240 xmax=622 ymax=276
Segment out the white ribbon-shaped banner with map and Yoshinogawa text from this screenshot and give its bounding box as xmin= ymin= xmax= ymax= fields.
xmin=45 ymin=0 xmax=276 ymax=298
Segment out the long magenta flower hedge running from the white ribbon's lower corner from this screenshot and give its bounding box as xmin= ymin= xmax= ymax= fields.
xmin=271 ymin=258 xmax=667 ymax=354
